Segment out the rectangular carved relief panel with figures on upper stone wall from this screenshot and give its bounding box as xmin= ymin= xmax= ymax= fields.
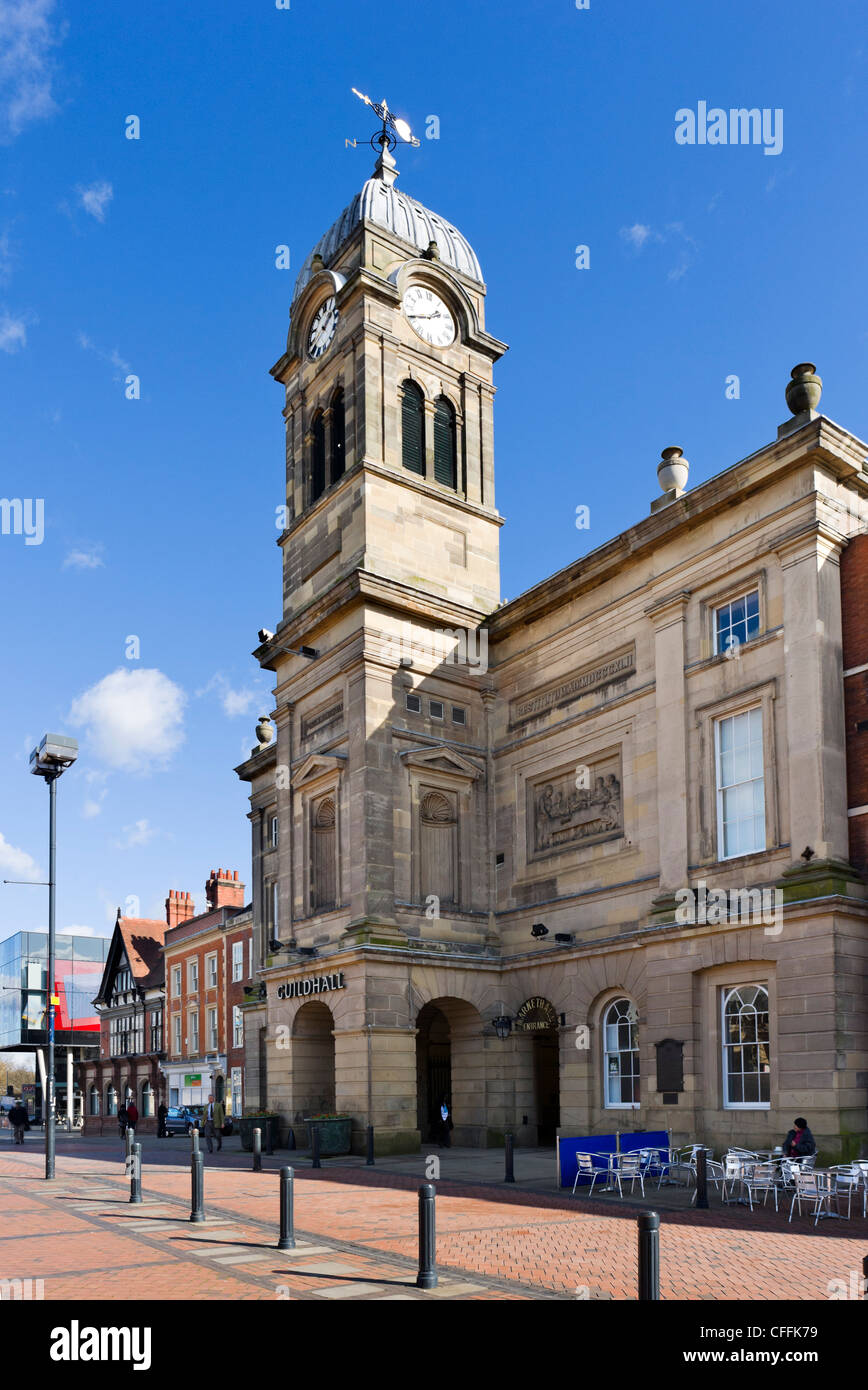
xmin=529 ymin=755 xmax=623 ymax=855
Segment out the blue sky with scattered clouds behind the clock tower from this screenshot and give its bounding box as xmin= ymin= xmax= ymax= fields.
xmin=0 ymin=0 xmax=868 ymax=935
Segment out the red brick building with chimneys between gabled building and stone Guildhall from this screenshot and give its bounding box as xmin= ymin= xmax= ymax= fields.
xmin=163 ymin=869 xmax=253 ymax=1115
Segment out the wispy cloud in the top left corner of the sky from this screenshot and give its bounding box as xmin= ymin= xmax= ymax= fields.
xmin=0 ymin=0 xmax=58 ymax=145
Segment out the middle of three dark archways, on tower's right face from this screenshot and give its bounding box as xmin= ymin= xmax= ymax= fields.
xmin=416 ymin=998 xmax=485 ymax=1145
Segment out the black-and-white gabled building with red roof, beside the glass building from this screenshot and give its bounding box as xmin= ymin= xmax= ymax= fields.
xmin=82 ymin=909 xmax=167 ymax=1134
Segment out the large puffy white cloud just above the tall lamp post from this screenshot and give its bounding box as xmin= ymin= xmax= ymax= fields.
xmin=68 ymin=667 xmax=186 ymax=773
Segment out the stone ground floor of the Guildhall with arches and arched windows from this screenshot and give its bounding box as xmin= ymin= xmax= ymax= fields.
xmin=237 ymin=897 xmax=868 ymax=1161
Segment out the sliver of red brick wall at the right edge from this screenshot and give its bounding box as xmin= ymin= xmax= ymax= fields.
xmin=840 ymin=534 xmax=868 ymax=873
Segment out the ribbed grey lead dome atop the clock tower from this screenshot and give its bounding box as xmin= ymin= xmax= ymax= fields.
xmin=292 ymin=156 xmax=484 ymax=302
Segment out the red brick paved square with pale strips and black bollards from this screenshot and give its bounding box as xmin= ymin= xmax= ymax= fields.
xmin=0 ymin=1131 xmax=868 ymax=1302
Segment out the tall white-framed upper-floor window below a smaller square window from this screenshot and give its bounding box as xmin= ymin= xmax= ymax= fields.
xmin=715 ymin=706 xmax=765 ymax=859
